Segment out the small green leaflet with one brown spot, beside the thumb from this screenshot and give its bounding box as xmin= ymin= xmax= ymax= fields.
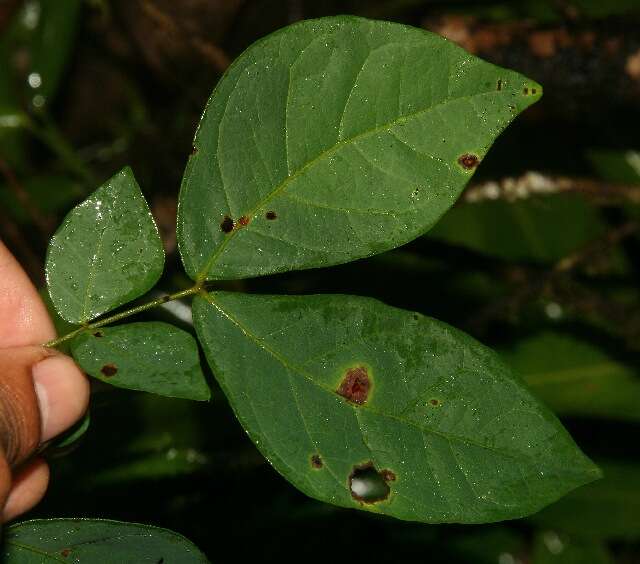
xmin=71 ymin=322 xmax=210 ymax=400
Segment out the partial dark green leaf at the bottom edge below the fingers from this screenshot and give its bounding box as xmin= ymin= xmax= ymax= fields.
xmin=2 ymin=519 xmax=208 ymax=564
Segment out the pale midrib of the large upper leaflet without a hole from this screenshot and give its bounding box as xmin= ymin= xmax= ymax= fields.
xmin=196 ymin=90 xmax=503 ymax=282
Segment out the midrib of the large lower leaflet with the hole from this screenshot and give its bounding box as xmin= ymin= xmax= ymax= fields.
xmin=200 ymin=293 xmax=527 ymax=460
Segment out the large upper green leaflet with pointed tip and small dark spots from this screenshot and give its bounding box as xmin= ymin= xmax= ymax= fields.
xmin=178 ymin=16 xmax=542 ymax=280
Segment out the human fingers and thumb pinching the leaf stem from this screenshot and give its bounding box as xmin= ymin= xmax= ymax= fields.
xmin=0 ymin=241 xmax=89 ymax=522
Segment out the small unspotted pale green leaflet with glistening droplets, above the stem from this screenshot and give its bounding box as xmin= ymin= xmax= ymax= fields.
xmin=46 ymin=168 xmax=164 ymax=323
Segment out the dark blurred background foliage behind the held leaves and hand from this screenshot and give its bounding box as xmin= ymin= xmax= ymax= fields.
xmin=0 ymin=0 xmax=640 ymax=564
